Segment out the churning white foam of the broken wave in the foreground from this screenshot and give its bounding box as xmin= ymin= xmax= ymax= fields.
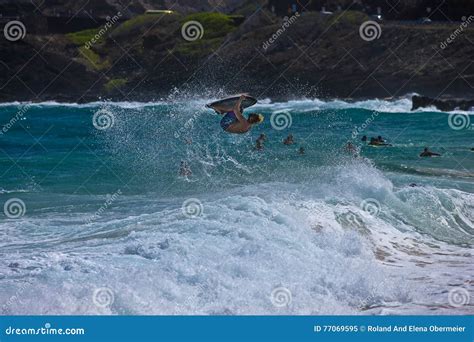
xmin=0 ymin=162 xmax=474 ymax=314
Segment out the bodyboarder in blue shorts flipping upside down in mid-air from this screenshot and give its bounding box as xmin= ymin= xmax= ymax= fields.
xmin=212 ymin=95 xmax=263 ymax=134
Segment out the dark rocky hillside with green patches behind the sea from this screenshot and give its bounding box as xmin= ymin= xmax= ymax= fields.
xmin=0 ymin=0 xmax=474 ymax=102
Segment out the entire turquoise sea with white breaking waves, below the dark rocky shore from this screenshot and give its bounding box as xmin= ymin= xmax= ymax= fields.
xmin=0 ymin=99 xmax=474 ymax=315
